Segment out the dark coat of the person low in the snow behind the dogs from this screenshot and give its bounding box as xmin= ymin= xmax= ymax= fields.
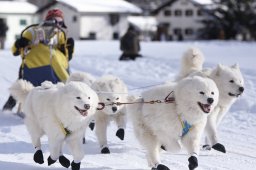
xmin=120 ymin=30 xmax=140 ymax=54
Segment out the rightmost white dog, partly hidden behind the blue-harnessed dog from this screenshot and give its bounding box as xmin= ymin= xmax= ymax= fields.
xmin=178 ymin=49 xmax=244 ymax=153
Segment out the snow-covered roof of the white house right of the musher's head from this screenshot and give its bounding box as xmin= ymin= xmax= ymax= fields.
xmin=58 ymin=0 xmax=142 ymax=13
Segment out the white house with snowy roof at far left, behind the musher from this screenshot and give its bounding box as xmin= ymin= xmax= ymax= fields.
xmin=0 ymin=1 xmax=37 ymax=42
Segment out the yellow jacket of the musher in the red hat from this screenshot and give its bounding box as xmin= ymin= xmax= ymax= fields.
xmin=12 ymin=26 xmax=69 ymax=82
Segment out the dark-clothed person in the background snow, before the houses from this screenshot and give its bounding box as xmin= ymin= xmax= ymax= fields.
xmin=119 ymin=26 xmax=142 ymax=60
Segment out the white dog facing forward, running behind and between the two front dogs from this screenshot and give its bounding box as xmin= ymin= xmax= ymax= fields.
xmin=92 ymin=75 xmax=128 ymax=154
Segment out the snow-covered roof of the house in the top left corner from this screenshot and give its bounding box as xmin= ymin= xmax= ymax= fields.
xmin=0 ymin=1 xmax=37 ymax=14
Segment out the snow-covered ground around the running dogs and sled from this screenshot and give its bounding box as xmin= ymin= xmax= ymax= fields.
xmin=0 ymin=41 xmax=256 ymax=170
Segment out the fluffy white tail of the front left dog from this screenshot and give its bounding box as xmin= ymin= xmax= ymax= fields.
xmin=9 ymin=80 xmax=34 ymax=103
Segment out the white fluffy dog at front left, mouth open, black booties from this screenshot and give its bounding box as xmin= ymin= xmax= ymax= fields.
xmin=10 ymin=80 xmax=99 ymax=170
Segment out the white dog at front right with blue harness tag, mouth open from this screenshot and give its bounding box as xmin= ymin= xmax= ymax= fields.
xmin=127 ymin=76 xmax=219 ymax=170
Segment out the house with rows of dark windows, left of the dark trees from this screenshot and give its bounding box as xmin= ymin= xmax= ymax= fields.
xmin=153 ymin=0 xmax=209 ymax=40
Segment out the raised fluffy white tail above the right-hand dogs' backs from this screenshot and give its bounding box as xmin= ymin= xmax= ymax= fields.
xmin=176 ymin=47 xmax=204 ymax=80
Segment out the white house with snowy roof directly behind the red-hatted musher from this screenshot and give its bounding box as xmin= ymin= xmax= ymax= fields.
xmin=38 ymin=0 xmax=142 ymax=40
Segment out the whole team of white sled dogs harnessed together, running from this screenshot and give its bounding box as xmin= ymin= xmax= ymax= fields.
xmin=10 ymin=48 xmax=244 ymax=170
